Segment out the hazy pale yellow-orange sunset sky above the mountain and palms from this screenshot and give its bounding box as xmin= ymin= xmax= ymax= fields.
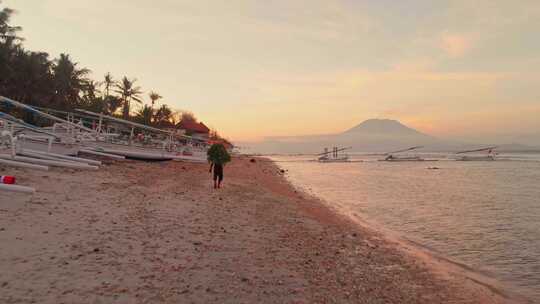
xmin=3 ymin=0 xmax=540 ymax=144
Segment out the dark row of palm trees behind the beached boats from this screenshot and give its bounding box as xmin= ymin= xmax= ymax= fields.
xmin=0 ymin=0 xmax=196 ymax=127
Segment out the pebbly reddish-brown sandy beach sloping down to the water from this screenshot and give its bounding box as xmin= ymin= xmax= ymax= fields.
xmin=0 ymin=157 xmax=524 ymax=304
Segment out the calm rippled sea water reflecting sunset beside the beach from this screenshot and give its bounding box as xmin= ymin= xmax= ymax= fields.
xmin=272 ymin=154 xmax=540 ymax=303
